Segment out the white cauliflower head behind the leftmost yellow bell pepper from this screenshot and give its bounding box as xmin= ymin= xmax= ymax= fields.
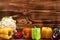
xmin=0 ymin=16 xmax=16 ymax=31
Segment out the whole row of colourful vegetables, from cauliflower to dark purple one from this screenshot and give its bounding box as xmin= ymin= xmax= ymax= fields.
xmin=0 ymin=16 xmax=60 ymax=40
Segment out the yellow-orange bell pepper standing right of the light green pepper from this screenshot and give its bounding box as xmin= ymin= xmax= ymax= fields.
xmin=42 ymin=27 xmax=52 ymax=38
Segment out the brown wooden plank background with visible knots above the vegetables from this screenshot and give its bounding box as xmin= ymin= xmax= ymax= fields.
xmin=0 ymin=0 xmax=60 ymax=28
